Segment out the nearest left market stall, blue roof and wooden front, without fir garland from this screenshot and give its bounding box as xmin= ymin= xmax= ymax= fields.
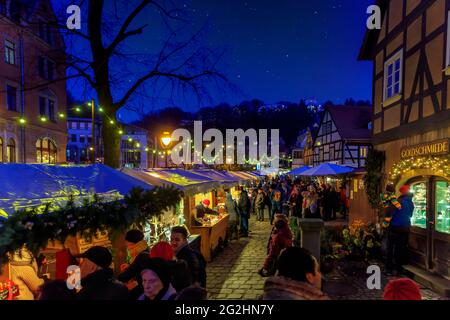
xmin=0 ymin=164 xmax=158 ymax=279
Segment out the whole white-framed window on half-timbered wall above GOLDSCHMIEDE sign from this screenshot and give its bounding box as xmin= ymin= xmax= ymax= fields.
xmin=384 ymin=50 xmax=403 ymax=101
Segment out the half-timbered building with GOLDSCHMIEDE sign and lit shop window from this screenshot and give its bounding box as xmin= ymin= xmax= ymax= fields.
xmin=360 ymin=0 xmax=450 ymax=278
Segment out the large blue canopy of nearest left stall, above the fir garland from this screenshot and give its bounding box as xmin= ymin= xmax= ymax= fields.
xmin=0 ymin=164 xmax=153 ymax=217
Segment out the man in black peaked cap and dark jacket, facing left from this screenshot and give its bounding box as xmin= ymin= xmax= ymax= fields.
xmin=76 ymin=246 xmax=128 ymax=300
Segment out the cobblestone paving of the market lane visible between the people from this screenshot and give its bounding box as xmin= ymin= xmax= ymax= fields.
xmin=207 ymin=212 xmax=446 ymax=300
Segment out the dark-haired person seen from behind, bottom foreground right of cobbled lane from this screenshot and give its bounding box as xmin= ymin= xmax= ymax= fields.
xmin=263 ymin=247 xmax=329 ymax=300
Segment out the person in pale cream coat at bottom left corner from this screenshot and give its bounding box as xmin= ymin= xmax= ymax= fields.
xmin=9 ymin=247 xmax=44 ymax=300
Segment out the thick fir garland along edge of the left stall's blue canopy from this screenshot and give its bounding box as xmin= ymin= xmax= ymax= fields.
xmin=0 ymin=187 xmax=181 ymax=267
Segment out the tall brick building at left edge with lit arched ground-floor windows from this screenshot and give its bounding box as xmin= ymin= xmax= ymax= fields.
xmin=0 ymin=0 xmax=67 ymax=163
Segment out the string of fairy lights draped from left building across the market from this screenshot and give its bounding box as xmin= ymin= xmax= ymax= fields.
xmin=14 ymin=102 xmax=293 ymax=166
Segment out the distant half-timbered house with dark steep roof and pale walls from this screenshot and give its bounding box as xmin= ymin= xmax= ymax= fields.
xmin=313 ymin=106 xmax=372 ymax=168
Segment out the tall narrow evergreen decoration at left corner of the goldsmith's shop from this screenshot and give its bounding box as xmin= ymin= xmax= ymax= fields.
xmin=364 ymin=149 xmax=386 ymax=209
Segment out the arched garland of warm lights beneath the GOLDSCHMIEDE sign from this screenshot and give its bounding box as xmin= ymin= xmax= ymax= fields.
xmin=389 ymin=157 xmax=450 ymax=183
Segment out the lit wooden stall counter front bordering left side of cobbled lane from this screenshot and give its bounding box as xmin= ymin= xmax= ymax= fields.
xmin=191 ymin=214 xmax=230 ymax=262
